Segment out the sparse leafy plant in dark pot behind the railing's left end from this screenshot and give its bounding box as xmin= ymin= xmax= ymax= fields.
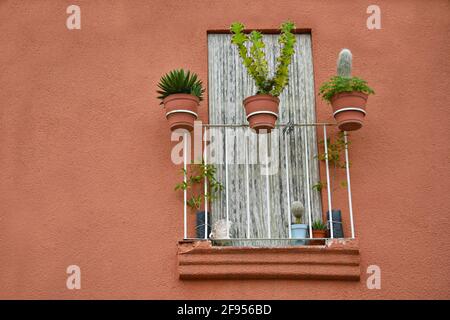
xmin=175 ymin=162 xmax=223 ymax=238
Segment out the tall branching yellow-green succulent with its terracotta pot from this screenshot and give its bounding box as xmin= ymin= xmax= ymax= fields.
xmin=230 ymin=22 xmax=296 ymax=132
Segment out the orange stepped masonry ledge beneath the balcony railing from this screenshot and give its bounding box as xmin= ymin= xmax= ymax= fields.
xmin=178 ymin=239 xmax=361 ymax=281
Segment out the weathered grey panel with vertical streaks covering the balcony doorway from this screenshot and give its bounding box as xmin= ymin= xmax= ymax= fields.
xmin=208 ymin=34 xmax=322 ymax=245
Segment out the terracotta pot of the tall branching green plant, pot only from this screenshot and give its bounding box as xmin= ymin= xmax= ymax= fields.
xmin=244 ymin=94 xmax=280 ymax=132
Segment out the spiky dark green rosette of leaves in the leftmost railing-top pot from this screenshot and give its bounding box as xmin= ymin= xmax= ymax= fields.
xmin=156 ymin=69 xmax=205 ymax=104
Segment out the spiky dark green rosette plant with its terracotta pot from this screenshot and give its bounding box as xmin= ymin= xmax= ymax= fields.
xmin=157 ymin=69 xmax=205 ymax=131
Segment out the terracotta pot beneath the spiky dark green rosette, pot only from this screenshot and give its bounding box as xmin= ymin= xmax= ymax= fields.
xmin=163 ymin=93 xmax=200 ymax=131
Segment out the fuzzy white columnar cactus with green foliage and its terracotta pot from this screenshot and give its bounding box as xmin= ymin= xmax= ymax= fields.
xmin=319 ymin=49 xmax=375 ymax=131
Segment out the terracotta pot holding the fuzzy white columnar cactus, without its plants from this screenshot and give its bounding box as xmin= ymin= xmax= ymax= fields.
xmin=331 ymin=91 xmax=367 ymax=131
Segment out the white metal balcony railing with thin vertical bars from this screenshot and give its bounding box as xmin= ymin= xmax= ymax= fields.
xmin=179 ymin=123 xmax=355 ymax=244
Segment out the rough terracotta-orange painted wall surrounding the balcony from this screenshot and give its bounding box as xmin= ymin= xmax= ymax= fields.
xmin=0 ymin=0 xmax=450 ymax=299
